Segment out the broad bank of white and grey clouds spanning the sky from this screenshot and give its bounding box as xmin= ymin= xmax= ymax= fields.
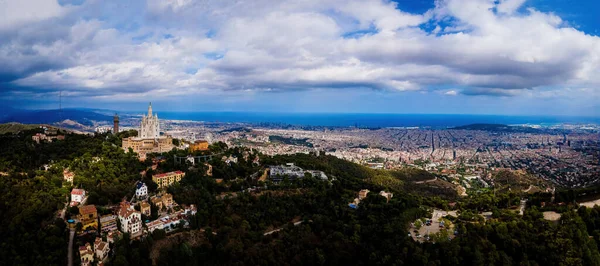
xmin=0 ymin=0 xmax=600 ymax=103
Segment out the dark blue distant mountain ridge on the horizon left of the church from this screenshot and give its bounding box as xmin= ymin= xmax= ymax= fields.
xmin=0 ymin=109 xmax=112 ymax=126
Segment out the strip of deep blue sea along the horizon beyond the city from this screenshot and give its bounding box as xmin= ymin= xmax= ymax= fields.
xmin=152 ymin=112 xmax=600 ymax=128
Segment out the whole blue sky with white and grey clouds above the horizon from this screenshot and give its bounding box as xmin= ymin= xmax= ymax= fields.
xmin=0 ymin=0 xmax=600 ymax=117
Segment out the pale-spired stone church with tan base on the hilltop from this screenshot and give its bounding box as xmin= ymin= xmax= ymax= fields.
xmin=122 ymin=103 xmax=174 ymax=160
